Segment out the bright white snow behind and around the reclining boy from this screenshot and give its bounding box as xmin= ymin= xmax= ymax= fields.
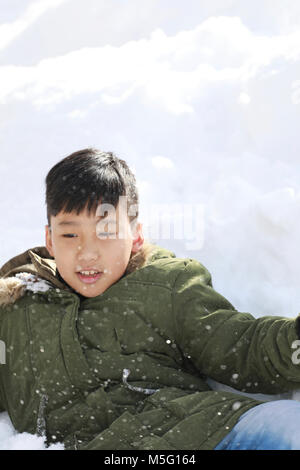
xmin=0 ymin=0 xmax=300 ymax=449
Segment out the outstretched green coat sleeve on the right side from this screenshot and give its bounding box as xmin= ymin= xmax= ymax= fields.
xmin=172 ymin=259 xmax=300 ymax=394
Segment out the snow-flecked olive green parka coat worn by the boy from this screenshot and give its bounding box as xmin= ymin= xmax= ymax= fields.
xmin=0 ymin=247 xmax=300 ymax=450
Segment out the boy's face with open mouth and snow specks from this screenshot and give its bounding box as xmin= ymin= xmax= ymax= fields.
xmin=45 ymin=206 xmax=144 ymax=297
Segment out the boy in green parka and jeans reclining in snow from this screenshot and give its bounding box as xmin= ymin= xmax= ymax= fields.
xmin=0 ymin=149 xmax=300 ymax=450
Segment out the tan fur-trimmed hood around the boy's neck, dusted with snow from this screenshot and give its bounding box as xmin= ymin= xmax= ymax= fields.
xmin=0 ymin=242 xmax=175 ymax=306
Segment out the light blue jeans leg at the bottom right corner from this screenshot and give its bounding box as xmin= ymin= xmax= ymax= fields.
xmin=215 ymin=400 xmax=300 ymax=450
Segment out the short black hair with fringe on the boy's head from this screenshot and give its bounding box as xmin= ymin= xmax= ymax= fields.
xmin=46 ymin=148 xmax=138 ymax=226
